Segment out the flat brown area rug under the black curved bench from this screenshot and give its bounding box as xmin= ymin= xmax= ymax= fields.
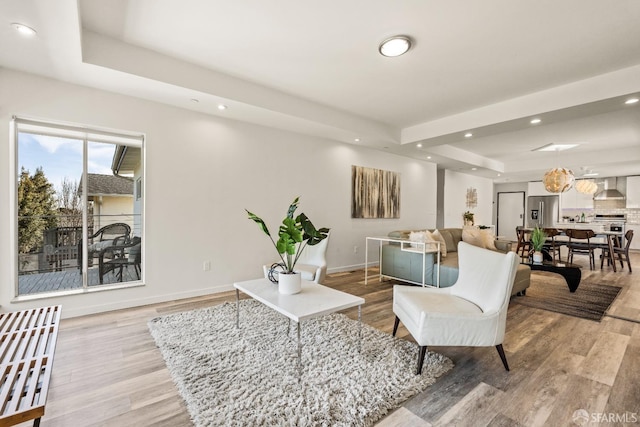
xmin=512 ymin=272 xmax=622 ymax=322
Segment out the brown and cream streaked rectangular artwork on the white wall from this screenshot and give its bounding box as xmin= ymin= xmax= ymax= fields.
xmin=351 ymin=166 xmax=400 ymax=218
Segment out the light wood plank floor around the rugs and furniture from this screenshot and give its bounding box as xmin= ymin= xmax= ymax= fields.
xmin=17 ymin=253 xmax=640 ymax=427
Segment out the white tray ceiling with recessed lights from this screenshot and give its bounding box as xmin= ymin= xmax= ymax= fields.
xmin=0 ymin=0 xmax=640 ymax=182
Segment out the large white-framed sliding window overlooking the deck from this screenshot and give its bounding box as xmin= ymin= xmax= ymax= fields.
xmin=12 ymin=118 xmax=144 ymax=296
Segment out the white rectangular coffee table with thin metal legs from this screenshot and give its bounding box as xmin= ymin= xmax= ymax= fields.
xmin=233 ymin=279 xmax=364 ymax=367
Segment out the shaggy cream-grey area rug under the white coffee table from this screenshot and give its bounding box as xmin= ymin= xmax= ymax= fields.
xmin=149 ymin=300 xmax=453 ymax=426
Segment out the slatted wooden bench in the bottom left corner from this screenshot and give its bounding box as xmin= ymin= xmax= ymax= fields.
xmin=0 ymin=305 xmax=62 ymax=427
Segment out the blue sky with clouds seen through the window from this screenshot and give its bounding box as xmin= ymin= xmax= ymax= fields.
xmin=17 ymin=133 xmax=116 ymax=194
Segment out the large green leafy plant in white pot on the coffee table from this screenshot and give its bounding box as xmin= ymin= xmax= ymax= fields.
xmin=245 ymin=197 xmax=329 ymax=294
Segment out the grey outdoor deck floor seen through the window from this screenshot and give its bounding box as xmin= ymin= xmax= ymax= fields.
xmin=18 ymin=265 xmax=138 ymax=295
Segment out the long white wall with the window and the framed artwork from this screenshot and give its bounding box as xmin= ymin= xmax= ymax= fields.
xmin=0 ymin=69 xmax=440 ymax=317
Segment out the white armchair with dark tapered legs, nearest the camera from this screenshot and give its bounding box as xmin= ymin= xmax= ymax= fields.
xmin=393 ymin=242 xmax=519 ymax=374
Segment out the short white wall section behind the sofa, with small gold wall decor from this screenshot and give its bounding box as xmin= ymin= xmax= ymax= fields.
xmin=444 ymin=170 xmax=494 ymax=228
